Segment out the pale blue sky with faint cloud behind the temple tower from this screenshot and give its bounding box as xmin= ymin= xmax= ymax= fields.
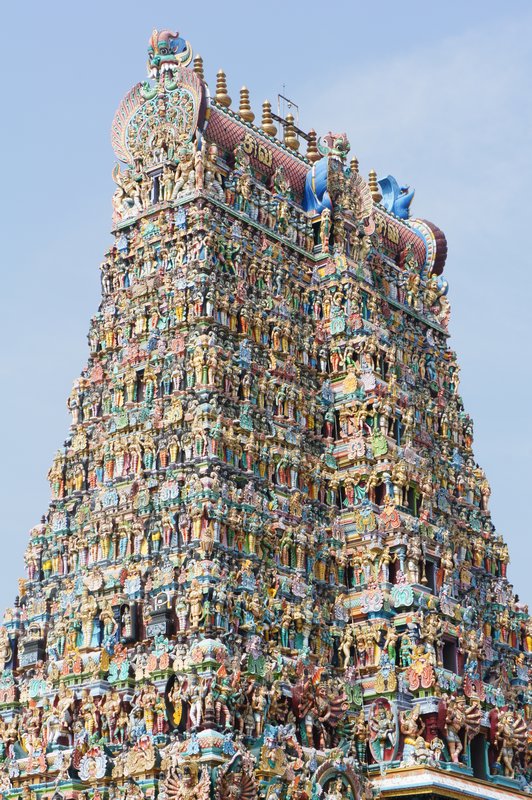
xmin=0 ymin=0 xmax=532 ymax=611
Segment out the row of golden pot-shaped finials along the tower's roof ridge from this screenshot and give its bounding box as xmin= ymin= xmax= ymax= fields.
xmin=193 ymin=55 xmax=382 ymax=198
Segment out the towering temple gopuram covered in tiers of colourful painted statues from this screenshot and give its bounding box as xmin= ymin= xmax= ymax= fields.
xmin=0 ymin=30 xmax=532 ymax=800
